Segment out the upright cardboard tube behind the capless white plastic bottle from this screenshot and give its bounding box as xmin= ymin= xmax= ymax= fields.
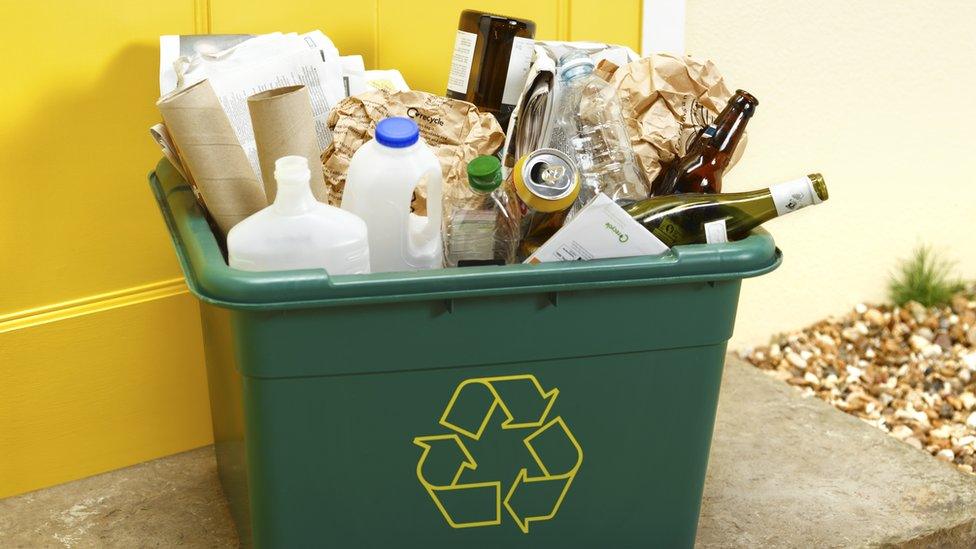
xmin=247 ymin=85 xmax=329 ymax=203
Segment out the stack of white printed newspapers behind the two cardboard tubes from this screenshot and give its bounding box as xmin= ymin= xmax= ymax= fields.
xmin=160 ymin=31 xmax=346 ymax=179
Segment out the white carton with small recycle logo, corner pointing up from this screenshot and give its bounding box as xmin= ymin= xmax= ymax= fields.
xmin=525 ymin=193 xmax=668 ymax=263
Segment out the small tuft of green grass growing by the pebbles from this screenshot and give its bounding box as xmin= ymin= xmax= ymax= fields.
xmin=888 ymin=246 xmax=964 ymax=307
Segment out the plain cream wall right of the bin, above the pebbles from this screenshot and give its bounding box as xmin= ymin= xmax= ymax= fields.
xmin=687 ymin=0 xmax=976 ymax=348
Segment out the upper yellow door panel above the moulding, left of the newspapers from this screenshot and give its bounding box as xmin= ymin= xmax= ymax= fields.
xmin=0 ymin=0 xmax=194 ymax=315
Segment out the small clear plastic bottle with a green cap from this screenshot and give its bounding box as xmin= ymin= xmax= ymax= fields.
xmin=444 ymin=156 xmax=519 ymax=267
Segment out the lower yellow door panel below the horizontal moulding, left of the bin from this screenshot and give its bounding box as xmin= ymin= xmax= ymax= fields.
xmin=0 ymin=290 xmax=212 ymax=498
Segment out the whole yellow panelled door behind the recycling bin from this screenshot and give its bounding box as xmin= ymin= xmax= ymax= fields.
xmin=0 ymin=0 xmax=640 ymax=497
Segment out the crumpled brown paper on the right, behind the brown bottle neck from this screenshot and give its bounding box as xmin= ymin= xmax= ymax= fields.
xmin=610 ymin=53 xmax=747 ymax=181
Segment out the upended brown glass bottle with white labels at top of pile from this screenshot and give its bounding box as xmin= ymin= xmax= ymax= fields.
xmin=447 ymin=10 xmax=535 ymax=131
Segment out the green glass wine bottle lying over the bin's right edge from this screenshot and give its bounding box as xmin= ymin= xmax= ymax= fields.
xmin=624 ymin=173 xmax=827 ymax=246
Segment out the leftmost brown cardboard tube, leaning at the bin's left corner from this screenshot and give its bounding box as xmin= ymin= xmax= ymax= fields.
xmin=156 ymin=80 xmax=268 ymax=236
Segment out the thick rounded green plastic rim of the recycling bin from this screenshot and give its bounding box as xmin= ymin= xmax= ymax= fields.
xmin=149 ymin=158 xmax=782 ymax=310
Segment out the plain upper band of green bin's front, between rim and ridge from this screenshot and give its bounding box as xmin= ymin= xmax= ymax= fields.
xmin=233 ymin=280 xmax=741 ymax=378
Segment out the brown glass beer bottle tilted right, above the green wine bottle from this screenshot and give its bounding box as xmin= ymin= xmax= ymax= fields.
xmin=651 ymin=90 xmax=759 ymax=196
